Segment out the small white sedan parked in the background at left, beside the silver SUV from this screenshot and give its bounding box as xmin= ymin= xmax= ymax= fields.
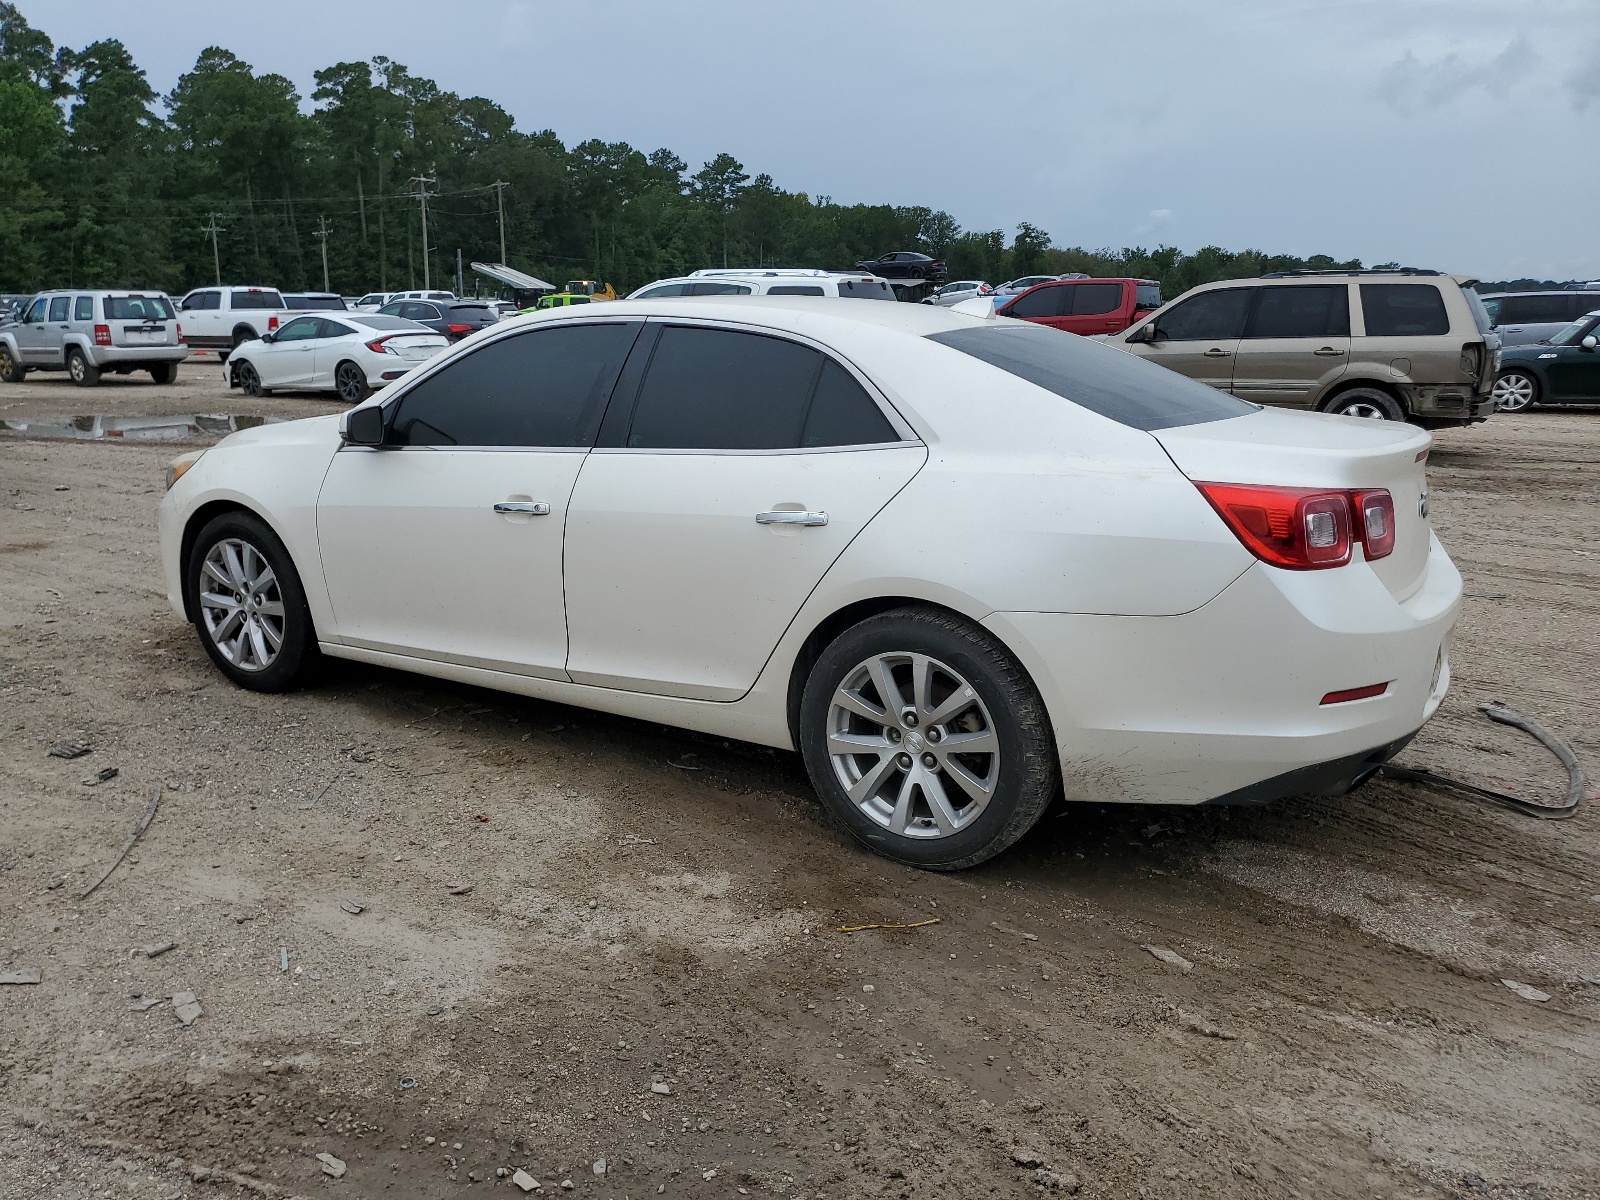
xmin=222 ymin=312 xmax=450 ymax=405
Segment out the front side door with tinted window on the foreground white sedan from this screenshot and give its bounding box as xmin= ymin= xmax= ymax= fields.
xmin=317 ymin=322 xmax=638 ymax=678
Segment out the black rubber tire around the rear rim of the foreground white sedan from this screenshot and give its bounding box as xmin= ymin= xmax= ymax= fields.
xmin=800 ymin=606 xmax=1061 ymax=870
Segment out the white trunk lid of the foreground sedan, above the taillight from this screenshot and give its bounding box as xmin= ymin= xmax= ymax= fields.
xmin=1150 ymin=408 xmax=1434 ymax=600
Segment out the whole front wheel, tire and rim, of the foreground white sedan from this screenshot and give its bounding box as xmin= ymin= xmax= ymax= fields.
xmin=184 ymin=510 xmax=318 ymax=691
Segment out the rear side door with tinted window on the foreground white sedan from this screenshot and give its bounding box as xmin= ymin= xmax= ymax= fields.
xmin=566 ymin=323 xmax=926 ymax=701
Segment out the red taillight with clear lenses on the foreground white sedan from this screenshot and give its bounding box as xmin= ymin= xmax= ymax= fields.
xmin=1195 ymin=483 xmax=1395 ymax=571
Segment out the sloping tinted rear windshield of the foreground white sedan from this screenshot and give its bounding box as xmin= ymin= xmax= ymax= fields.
xmin=928 ymin=325 xmax=1256 ymax=429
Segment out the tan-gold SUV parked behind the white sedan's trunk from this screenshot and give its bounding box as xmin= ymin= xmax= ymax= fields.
xmin=1106 ymin=269 xmax=1501 ymax=427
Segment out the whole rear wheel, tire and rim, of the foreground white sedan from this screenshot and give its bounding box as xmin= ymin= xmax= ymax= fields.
xmin=800 ymin=606 xmax=1061 ymax=870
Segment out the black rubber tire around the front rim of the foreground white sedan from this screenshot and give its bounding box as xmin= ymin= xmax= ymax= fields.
xmin=184 ymin=510 xmax=322 ymax=691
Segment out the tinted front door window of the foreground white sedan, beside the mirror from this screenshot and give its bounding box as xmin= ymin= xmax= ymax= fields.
xmin=389 ymin=323 xmax=638 ymax=446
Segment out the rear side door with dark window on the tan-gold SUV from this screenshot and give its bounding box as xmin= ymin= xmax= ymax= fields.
xmin=1234 ymin=283 xmax=1350 ymax=408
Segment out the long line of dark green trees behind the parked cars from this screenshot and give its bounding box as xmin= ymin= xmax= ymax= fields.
xmin=0 ymin=0 xmax=1360 ymax=305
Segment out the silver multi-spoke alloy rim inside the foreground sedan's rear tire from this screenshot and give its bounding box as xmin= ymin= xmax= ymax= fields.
xmin=827 ymin=653 xmax=1000 ymax=838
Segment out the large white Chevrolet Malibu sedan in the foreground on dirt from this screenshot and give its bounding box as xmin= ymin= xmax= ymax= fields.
xmin=160 ymin=298 xmax=1461 ymax=869
